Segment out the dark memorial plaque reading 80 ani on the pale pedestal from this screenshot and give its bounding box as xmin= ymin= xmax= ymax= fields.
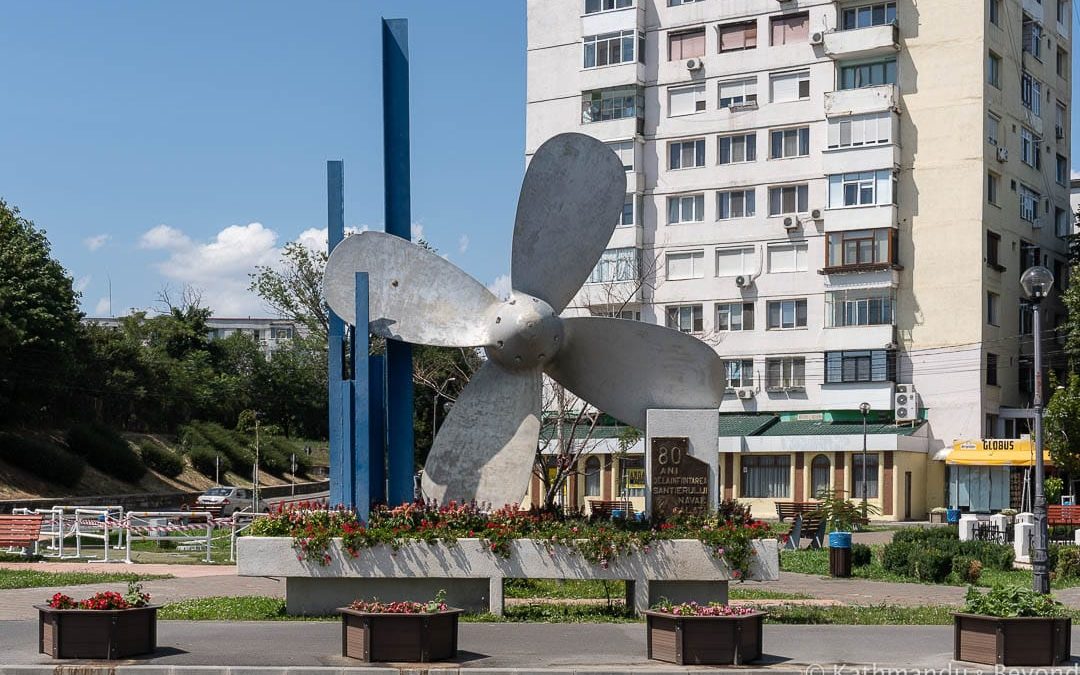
xmin=649 ymin=437 xmax=708 ymax=518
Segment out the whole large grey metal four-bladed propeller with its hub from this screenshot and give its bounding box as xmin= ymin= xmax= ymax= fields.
xmin=324 ymin=134 xmax=724 ymax=505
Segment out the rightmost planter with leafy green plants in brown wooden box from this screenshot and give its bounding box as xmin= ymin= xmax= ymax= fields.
xmin=953 ymin=586 xmax=1072 ymax=665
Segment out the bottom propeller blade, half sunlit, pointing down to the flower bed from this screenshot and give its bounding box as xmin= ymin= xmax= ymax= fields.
xmin=421 ymin=361 xmax=540 ymax=508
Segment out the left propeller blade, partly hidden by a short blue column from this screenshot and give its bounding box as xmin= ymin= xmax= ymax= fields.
xmin=323 ymin=232 xmax=499 ymax=347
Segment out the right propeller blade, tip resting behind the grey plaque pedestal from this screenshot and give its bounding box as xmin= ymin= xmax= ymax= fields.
xmin=545 ymin=316 xmax=725 ymax=429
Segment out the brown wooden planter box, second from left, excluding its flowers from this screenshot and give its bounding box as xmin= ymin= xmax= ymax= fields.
xmin=338 ymin=607 xmax=463 ymax=663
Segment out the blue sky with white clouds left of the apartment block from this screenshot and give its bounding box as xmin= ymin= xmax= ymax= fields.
xmin=0 ymin=0 xmax=525 ymax=315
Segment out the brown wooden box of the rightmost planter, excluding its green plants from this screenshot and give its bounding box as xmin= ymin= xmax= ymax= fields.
xmin=953 ymin=612 xmax=1072 ymax=665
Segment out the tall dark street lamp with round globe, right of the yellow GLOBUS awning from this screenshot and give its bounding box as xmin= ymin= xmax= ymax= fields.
xmin=1020 ymin=265 xmax=1054 ymax=594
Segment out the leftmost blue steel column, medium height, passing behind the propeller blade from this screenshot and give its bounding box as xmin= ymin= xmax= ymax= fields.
xmin=326 ymin=160 xmax=352 ymax=507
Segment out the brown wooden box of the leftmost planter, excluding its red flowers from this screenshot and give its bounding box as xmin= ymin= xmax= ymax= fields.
xmin=35 ymin=605 xmax=158 ymax=659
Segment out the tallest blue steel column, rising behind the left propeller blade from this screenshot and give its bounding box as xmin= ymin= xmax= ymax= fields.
xmin=382 ymin=18 xmax=414 ymax=504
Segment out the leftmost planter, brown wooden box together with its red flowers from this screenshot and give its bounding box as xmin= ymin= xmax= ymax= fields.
xmin=35 ymin=583 xmax=158 ymax=659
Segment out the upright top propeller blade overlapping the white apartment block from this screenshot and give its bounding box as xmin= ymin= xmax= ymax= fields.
xmin=510 ymin=134 xmax=626 ymax=314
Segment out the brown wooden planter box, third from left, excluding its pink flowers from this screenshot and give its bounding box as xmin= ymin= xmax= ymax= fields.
xmin=645 ymin=611 xmax=765 ymax=665
